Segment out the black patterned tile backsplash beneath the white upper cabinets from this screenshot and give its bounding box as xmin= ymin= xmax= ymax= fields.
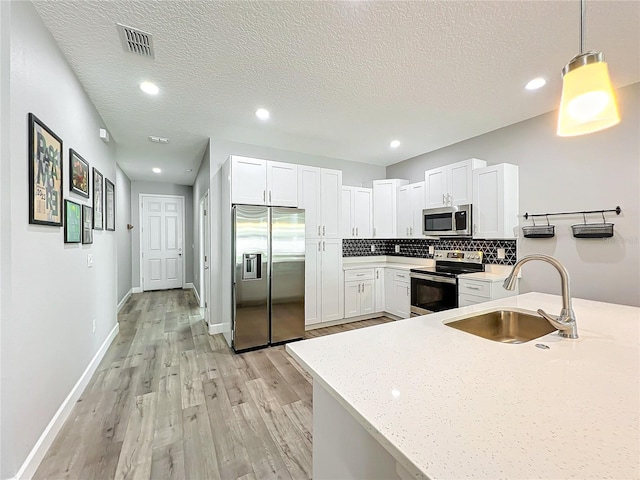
xmin=342 ymin=238 xmax=517 ymax=265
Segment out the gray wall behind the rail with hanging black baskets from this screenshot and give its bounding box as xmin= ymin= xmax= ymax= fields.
xmin=387 ymin=83 xmax=640 ymax=305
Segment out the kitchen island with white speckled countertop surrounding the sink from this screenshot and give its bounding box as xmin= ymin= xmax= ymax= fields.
xmin=287 ymin=293 xmax=640 ymax=480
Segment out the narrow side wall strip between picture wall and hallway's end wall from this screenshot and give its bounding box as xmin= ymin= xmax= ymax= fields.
xmin=116 ymin=165 xmax=132 ymax=304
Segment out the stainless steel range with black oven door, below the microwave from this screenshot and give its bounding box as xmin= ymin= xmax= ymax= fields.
xmin=411 ymin=250 xmax=484 ymax=317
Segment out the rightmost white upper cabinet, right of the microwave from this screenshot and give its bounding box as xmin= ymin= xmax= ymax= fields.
xmin=473 ymin=163 xmax=518 ymax=239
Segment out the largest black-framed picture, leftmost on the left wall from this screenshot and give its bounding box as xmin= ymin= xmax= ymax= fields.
xmin=28 ymin=113 xmax=63 ymax=227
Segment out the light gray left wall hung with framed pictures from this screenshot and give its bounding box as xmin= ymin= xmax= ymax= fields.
xmin=0 ymin=2 xmax=116 ymax=478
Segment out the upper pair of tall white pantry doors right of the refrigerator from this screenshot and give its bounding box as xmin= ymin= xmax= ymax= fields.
xmin=298 ymin=165 xmax=343 ymax=238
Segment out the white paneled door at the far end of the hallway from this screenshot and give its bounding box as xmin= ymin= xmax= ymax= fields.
xmin=140 ymin=196 xmax=184 ymax=291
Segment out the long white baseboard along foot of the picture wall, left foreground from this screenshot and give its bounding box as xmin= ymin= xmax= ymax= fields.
xmin=14 ymin=322 xmax=120 ymax=480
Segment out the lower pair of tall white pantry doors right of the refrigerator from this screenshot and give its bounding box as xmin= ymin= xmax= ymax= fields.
xmin=304 ymin=239 xmax=344 ymax=325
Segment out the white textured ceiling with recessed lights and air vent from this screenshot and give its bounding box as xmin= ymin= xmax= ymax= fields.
xmin=35 ymin=0 xmax=640 ymax=184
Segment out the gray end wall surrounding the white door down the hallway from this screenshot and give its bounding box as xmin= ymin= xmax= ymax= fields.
xmin=131 ymin=182 xmax=194 ymax=288
